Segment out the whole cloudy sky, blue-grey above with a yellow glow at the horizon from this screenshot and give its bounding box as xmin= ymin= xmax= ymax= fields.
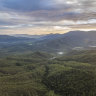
xmin=0 ymin=0 xmax=96 ymax=35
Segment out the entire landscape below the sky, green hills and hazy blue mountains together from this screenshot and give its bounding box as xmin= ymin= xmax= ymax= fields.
xmin=0 ymin=32 xmax=96 ymax=96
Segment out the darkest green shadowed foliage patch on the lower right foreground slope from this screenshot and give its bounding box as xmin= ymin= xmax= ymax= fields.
xmin=45 ymin=69 xmax=96 ymax=96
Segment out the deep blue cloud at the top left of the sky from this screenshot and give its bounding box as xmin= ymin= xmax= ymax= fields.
xmin=2 ymin=0 xmax=56 ymax=11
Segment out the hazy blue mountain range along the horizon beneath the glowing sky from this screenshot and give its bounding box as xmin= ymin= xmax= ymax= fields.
xmin=0 ymin=31 xmax=96 ymax=56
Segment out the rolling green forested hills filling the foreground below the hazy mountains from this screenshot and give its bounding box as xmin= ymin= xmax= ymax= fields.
xmin=0 ymin=50 xmax=96 ymax=96
